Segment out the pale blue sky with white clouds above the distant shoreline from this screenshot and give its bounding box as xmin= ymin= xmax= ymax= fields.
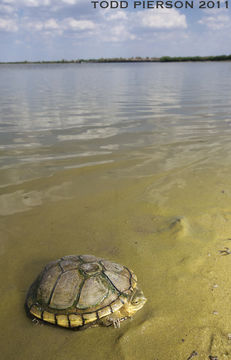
xmin=0 ymin=0 xmax=231 ymax=61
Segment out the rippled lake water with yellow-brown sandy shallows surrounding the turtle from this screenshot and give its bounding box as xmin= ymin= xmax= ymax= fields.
xmin=0 ymin=62 xmax=231 ymax=360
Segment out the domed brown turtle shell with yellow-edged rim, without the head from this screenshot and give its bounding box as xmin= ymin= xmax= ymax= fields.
xmin=26 ymin=255 xmax=137 ymax=328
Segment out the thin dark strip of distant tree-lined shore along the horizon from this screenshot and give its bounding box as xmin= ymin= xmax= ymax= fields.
xmin=0 ymin=55 xmax=231 ymax=65
